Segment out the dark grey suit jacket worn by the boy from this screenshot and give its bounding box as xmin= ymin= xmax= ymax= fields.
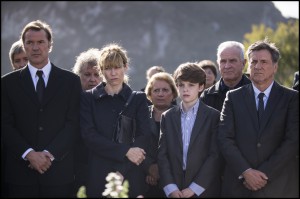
xmin=158 ymin=101 xmax=220 ymax=197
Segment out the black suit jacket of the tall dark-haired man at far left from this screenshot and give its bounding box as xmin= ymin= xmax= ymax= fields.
xmin=1 ymin=64 xmax=81 ymax=185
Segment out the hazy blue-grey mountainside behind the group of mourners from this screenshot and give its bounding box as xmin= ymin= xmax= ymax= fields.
xmin=1 ymin=1 xmax=287 ymax=90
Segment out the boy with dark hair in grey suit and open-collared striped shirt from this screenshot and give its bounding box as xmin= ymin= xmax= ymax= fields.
xmin=158 ymin=62 xmax=220 ymax=198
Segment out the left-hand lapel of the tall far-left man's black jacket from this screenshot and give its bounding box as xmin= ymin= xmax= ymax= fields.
xmin=20 ymin=65 xmax=39 ymax=104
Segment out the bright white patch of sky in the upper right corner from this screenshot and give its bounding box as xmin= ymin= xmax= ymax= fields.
xmin=272 ymin=1 xmax=299 ymax=19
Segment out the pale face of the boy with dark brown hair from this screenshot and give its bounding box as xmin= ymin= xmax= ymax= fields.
xmin=177 ymin=81 xmax=204 ymax=104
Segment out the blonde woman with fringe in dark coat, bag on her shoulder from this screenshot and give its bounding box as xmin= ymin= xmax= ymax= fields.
xmin=81 ymin=43 xmax=151 ymax=198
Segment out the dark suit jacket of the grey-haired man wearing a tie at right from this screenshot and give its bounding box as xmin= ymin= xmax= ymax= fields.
xmin=218 ymin=82 xmax=299 ymax=197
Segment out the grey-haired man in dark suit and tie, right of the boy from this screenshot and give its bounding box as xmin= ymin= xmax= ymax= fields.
xmin=218 ymin=40 xmax=299 ymax=198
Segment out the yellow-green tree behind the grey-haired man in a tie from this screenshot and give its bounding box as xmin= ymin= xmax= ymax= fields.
xmin=243 ymin=19 xmax=299 ymax=88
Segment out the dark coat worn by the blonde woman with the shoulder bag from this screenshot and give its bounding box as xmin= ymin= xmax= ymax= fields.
xmin=80 ymin=83 xmax=151 ymax=197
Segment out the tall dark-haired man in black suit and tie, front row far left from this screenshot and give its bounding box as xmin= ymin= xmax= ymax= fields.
xmin=1 ymin=20 xmax=81 ymax=198
